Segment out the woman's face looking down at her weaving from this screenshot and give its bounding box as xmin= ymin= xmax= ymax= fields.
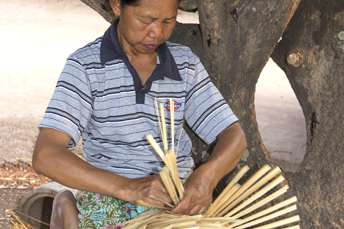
xmin=113 ymin=0 xmax=178 ymax=54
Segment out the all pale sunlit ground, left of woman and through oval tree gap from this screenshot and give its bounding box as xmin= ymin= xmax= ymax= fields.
xmin=0 ymin=0 xmax=305 ymax=228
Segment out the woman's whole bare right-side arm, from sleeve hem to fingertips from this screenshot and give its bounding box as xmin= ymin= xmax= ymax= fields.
xmin=174 ymin=123 xmax=246 ymax=215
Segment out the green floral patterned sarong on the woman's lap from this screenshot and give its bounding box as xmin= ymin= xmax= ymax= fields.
xmin=76 ymin=191 xmax=148 ymax=229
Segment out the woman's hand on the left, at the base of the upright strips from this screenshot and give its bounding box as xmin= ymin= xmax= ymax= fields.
xmin=123 ymin=174 xmax=172 ymax=208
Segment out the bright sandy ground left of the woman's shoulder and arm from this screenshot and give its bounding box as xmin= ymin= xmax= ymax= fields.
xmin=0 ymin=0 xmax=108 ymax=226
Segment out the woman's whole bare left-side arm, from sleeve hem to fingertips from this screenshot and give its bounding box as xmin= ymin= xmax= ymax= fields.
xmin=32 ymin=128 xmax=170 ymax=206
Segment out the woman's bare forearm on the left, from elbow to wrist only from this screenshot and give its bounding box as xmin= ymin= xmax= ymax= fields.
xmin=33 ymin=145 xmax=129 ymax=199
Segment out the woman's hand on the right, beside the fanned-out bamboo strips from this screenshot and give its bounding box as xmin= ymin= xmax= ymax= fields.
xmin=172 ymin=166 xmax=215 ymax=215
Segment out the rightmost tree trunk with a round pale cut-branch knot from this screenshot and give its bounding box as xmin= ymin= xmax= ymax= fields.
xmin=273 ymin=0 xmax=344 ymax=228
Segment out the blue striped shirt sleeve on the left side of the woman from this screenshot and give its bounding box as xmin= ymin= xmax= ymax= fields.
xmin=39 ymin=57 xmax=93 ymax=147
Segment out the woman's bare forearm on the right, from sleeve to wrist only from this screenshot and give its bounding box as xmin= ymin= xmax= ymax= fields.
xmin=195 ymin=123 xmax=246 ymax=191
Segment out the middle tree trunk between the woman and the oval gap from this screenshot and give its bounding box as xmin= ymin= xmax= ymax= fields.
xmin=199 ymin=0 xmax=300 ymax=167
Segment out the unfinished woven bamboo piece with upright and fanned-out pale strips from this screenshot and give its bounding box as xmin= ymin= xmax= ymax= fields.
xmin=124 ymin=99 xmax=300 ymax=229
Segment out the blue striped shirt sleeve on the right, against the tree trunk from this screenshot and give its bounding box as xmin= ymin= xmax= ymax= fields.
xmin=185 ymin=52 xmax=238 ymax=144
